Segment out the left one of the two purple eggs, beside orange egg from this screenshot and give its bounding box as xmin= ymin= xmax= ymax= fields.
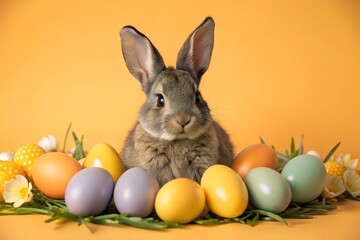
xmin=65 ymin=167 xmax=114 ymax=217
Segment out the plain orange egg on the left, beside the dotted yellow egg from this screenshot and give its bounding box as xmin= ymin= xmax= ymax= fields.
xmin=32 ymin=152 xmax=82 ymax=199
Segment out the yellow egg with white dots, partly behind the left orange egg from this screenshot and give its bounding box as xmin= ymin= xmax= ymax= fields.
xmin=14 ymin=144 xmax=46 ymax=178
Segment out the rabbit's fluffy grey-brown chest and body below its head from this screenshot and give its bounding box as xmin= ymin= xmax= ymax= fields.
xmin=121 ymin=122 xmax=233 ymax=185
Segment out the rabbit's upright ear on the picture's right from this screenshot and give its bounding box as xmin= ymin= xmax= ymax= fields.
xmin=176 ymin=17 xmax=215 ymax=84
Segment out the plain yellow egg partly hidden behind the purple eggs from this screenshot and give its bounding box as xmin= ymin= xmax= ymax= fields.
xmin=83 ymin=143 xmax=124 ymax=183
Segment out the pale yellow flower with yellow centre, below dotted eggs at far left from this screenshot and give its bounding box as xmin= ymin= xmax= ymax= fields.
xmin=3 ymin=175 xmax=33 ymax=208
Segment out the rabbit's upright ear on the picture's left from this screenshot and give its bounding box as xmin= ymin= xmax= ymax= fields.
xmin=120 ymin=26 xmax=165 ymax=93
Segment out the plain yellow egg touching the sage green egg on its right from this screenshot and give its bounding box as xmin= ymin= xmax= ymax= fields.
xmin=201 ymin=164 xmax=249 ymax=218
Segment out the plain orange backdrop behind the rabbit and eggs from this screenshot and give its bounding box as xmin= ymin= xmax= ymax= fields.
xmin=0 ymin=0 xmax=360 ymax=157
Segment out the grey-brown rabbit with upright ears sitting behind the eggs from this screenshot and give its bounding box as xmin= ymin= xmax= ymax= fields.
xmin=120 ymin=17 xmax=234 ymax=186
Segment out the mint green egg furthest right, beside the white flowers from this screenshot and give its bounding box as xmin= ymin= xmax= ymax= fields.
xmin=281 ymin=154 xmax=326 ymax=204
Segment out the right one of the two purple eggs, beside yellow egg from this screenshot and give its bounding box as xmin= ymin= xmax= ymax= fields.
xmin=114 ymin=167 xmax=159 ymax=217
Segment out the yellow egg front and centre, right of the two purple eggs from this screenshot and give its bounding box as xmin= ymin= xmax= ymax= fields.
xmin=155 ymin=178 xmax=205 ymax=224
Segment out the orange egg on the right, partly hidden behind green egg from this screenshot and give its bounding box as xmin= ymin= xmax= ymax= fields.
xmin=231 ymin=144 xmax=277 ymax=179
